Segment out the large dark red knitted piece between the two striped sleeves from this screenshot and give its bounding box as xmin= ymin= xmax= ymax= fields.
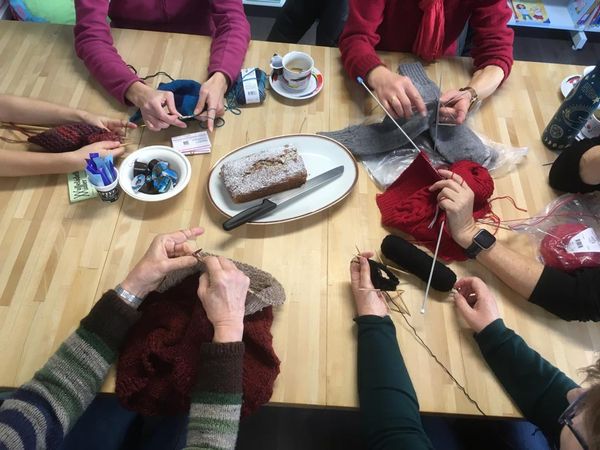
xmin=116 ymin=274 xmax=279 ymax=416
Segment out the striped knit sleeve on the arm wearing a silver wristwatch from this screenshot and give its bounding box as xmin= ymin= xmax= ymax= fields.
xmin=0 ymin=291 xmax=139 ymax=450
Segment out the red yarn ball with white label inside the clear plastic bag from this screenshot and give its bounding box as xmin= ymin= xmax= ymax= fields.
xmin=540 ymin=223 xmax=600 ymax=271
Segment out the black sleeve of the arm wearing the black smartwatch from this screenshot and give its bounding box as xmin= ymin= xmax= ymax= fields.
xmin=529 ymin=266 xmax=600 ymax=322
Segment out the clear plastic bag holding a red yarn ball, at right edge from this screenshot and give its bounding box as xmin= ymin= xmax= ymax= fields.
xmin=512 ymin=192 xmax=600 ymax=271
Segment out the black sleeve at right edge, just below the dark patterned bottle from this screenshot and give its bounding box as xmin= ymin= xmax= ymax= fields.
xmin=549 ymin=137 xmax=600 ymax=192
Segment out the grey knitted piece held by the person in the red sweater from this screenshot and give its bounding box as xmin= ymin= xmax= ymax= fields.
xmin=318 ymin=63 xmax=498 ymax=167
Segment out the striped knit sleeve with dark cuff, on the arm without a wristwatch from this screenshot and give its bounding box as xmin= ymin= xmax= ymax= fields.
xmin=185 ymin=342 xmax=244 ymax=450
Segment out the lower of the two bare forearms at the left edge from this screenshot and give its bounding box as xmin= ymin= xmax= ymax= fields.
xmin=0 ymin=149 xmax=85 ymax=177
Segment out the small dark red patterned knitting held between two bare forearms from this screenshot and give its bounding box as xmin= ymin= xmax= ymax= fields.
xmin=27 ymin=123 xmax=121 ymax=153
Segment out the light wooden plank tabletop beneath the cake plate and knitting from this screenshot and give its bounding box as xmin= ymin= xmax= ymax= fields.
xmin=0 ymin=22 xmax=600 ymax=416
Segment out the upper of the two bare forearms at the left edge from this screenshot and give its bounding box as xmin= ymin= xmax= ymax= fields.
xmin=0 ymin=95 xmax=87 ymax=125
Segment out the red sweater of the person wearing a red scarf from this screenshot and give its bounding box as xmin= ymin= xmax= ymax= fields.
xmin=339 ymin=0 xmax=514 ymax=79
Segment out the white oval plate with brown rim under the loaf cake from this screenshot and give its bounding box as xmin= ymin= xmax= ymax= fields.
xmin=207 ymin=134 xmax=358 ymax=225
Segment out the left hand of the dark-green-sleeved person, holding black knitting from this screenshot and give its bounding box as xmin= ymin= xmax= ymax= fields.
xmin=350 ymin=252 xmax=389 ymax=317
